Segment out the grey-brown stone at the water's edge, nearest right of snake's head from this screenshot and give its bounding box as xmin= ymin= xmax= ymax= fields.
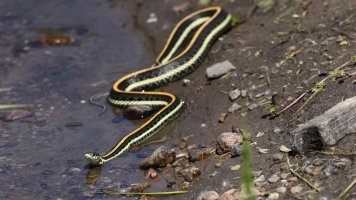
xmin=140 ymin=146 xmax=176 ymax=169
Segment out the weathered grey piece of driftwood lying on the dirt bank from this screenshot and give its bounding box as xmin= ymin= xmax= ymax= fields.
xmin=292 ymin=96 xmax=356 ymax=154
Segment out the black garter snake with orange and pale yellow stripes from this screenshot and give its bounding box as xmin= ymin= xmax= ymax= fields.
xmin=85 ymin=7 xmax=231 ymax=165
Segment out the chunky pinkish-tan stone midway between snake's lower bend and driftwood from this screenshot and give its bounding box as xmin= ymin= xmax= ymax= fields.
xmin=216 ymin=132 xmax=242 ymax=155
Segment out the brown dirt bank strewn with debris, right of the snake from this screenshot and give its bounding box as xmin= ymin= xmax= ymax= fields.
xmin=112 ymin=0 xmax=356 ymax=199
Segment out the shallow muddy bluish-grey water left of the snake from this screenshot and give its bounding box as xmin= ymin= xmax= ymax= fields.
xmin=0 ymin=0 xmax=163 ymax=199
